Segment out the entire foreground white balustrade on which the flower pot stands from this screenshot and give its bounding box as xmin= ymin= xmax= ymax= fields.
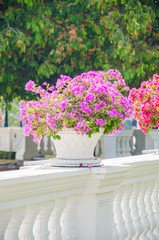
xmin=0 ymin=154 xmax=159 ymax=240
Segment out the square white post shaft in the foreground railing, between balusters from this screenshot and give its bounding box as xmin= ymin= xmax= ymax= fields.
xmin=77 ymin=191 xmax=113 ymax=240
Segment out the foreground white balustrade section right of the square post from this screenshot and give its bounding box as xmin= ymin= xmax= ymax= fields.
xmin=110 ymin=154 xmax=159 ymax=240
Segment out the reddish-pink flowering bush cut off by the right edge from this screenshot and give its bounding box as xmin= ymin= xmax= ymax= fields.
xmin=129 ymin=74 xmax=159 ymax=134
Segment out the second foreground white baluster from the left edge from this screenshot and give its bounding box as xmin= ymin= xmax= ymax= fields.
xmin=4 ymin=207 xmax=26 ymax=240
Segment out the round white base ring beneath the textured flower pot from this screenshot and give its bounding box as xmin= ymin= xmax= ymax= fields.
xmin=49 ymin=158 xmax=102 ymax=167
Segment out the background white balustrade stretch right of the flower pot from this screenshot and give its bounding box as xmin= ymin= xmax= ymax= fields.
xmin=95 ymin=129 xmax=159 ymax=159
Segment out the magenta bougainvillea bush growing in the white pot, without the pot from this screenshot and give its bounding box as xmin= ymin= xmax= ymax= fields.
xmin=20 ymin=69 xmax=133 ymax=141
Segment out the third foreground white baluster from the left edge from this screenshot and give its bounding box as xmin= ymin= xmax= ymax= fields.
xmin=19 ymin=204 xmax=40 ymax=240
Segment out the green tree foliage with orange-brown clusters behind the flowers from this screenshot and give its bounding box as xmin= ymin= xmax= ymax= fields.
xmin=0 ymin=0 xmax=159 ymax=101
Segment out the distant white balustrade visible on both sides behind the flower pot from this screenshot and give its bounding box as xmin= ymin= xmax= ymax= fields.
xmin=0 ymin=127 xmax=159 ymax=160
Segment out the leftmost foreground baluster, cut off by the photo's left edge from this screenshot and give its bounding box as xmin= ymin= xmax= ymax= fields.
xmin=0 ymin=210 xmax=11 ymax=240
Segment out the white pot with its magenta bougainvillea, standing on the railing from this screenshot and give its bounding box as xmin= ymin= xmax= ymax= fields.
xmin=20 ymin=69 xmax=132 ymax=166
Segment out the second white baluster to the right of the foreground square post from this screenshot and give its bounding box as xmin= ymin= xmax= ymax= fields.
xmin=129 ymin=183 xmax=143 ymax=240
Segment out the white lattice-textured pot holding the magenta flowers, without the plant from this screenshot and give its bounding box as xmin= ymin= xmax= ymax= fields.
xmin=50 ymin=128 xmax=103 ymax=167
